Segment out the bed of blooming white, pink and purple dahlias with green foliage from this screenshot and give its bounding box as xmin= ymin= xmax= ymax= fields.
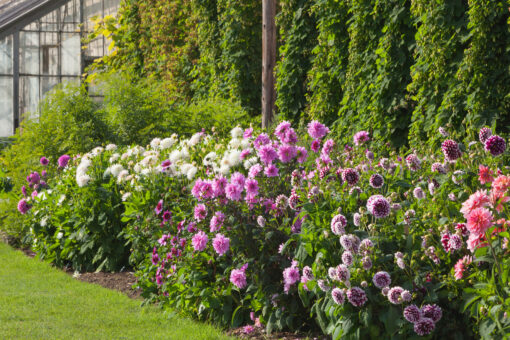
xmin=13 ymin=121 xmax=510 ymax=339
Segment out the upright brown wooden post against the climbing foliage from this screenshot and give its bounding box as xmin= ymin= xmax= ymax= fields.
xmin=262 ymin=0 xmax=276 ymax=128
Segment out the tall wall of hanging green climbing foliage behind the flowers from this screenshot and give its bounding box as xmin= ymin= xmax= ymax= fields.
xmin=96 ymin=0 xmax=510 ymax=146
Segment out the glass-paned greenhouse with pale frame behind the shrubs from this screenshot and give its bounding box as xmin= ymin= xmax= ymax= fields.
xmin=0 ymin=0 xmax=120 ymax=137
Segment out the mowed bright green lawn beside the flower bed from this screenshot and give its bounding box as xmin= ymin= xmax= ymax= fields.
xmin=0 ymin=242 xmax=231 ymax=339
